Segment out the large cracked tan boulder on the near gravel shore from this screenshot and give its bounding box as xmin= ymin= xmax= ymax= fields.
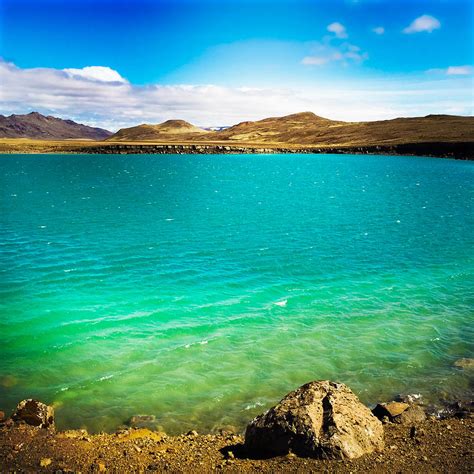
xmin=245 ymin=380 xmax=384 ymax=459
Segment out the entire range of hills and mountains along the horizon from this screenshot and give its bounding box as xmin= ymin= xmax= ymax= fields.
xmin=0 ymin=112 xmax=474 ymax=147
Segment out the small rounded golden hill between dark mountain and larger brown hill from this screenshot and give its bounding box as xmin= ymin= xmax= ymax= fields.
xmin=109 ymin=120 xmax=208 ymax=141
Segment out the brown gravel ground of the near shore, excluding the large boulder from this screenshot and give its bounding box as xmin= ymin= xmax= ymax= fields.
xmin=0 ymin=396 xmax=474 ymax=473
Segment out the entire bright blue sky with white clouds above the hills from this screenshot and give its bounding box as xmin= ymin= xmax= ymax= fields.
xmin=0 ymin=0 xmax=474 ymax=131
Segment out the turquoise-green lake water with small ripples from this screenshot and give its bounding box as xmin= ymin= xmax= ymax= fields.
xmin=0 ymin=155 xmax=474 ymax=433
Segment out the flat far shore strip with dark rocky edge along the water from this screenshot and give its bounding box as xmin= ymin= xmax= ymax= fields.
xmin=0 ymin=138 xmax=474 ymax=160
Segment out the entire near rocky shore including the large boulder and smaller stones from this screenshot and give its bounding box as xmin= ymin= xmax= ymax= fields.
xmin=0 ymin=381 xmax=474 ymax=473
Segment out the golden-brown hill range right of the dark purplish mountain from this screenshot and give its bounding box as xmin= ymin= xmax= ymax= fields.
xmin=109 ymin=112 xmax=474 ymax=146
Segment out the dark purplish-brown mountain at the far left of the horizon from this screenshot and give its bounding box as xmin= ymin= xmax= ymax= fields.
xmin=0 ymin=112 xmax=112 ymax=140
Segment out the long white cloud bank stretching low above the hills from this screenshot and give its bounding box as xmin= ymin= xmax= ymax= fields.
xmin=0 ymin=59 xmax=472 ymax=130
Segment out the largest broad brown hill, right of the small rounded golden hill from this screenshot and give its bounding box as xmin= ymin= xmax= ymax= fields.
xmin=203 ymin=112 xmax=474 ymax=146
